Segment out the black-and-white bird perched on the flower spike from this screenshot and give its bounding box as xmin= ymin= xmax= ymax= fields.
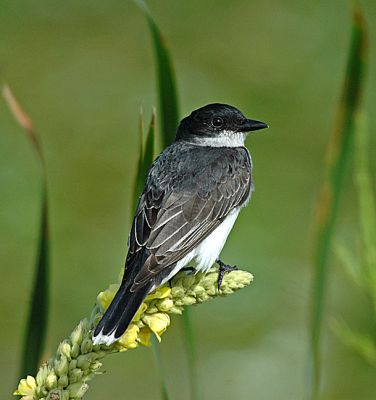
xmin=93 ymin=103 xmax=268 ymax=345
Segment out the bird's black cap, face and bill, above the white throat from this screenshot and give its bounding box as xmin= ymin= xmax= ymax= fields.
xmin=176 ymin=103 xmax=268 ymax=140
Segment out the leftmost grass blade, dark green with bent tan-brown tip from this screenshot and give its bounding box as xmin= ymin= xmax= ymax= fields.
xmin=2 ymin=85 xmax=49 ymax=376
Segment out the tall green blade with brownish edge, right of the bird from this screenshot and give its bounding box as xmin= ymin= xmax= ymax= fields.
xmin=309 ymin=6 xmax=367 ymax=399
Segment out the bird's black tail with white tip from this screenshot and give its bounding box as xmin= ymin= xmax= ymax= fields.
xmin=93 ymin=281 xmax=150 ymax=345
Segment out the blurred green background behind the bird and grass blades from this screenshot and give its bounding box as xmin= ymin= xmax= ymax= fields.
xmin=0 ymin=0 xmax=376 ymax=400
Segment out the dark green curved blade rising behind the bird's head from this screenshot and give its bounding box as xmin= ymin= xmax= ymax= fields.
xmin=135 ymin=0 xmax=179 ymax=147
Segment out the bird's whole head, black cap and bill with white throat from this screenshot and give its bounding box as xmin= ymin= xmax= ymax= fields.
xmin=176 ymin=103 xmax=268 ymax=147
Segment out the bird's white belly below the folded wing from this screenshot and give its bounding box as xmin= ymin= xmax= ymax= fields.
xmin=162 ymin=207 xmax=240 ymax=283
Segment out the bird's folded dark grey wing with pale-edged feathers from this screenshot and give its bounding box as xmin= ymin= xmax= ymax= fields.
xmin=124 ymin=144 xmax=251 ymax=292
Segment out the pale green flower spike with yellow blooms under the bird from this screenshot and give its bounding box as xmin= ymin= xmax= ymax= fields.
xmin=15 ymin=269 xmax=253 ymax=400
